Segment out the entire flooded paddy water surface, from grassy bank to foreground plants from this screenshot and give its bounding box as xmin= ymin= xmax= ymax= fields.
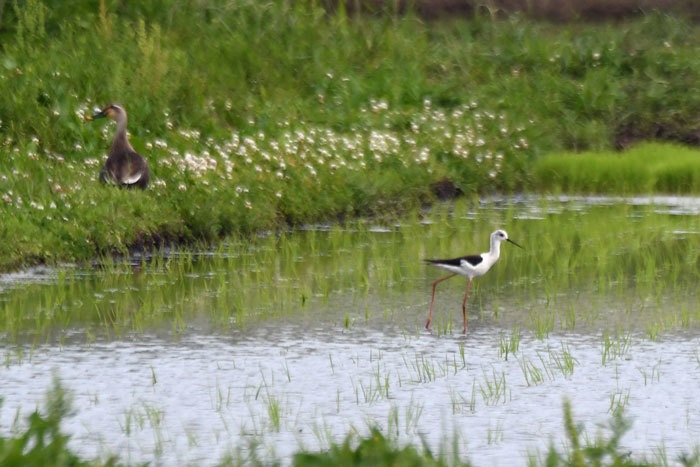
xmin=0 ymin=198 xmax=700 ymax=465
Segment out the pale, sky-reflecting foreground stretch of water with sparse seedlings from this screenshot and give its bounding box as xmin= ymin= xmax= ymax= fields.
xmin=1 ymin=323 xmax=700 ymax=465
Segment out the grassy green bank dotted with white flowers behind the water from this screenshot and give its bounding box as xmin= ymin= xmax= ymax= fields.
xmin=0 ymin=0 xmax=700 ymax=270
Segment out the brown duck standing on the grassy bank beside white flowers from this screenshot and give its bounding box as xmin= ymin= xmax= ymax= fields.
xmin=87 ymin=104 xmax=151 ymax=189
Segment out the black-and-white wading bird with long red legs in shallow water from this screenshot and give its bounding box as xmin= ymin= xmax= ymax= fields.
xmin=425 ymin=230 xmax=523 ymax=334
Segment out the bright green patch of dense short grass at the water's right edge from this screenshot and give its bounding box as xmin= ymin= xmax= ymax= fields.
xmin=533 ymin=143 xmax=700 ymax=194
